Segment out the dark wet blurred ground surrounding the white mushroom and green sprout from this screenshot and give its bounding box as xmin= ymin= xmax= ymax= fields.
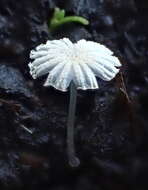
xmin=0 ymin=0 xmax=148 ymax=190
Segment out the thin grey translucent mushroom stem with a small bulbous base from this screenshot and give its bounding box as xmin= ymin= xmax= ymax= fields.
xmin=67 ymin=82 xmax=80 ymax=167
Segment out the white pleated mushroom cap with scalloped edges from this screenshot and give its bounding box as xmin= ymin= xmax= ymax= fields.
xmin=29 ymin=38 xmax=121 ymax=91
